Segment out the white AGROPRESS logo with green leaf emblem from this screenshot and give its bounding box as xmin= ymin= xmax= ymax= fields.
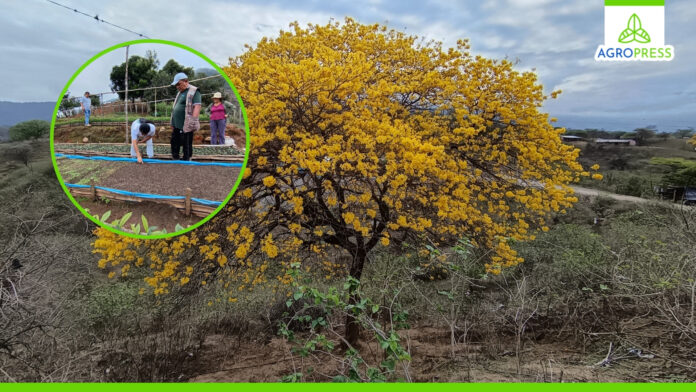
xmin=595 ymin=0 xmax=674 ymax=61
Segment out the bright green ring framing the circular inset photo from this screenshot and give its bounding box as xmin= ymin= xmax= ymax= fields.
xmin=50 ymin=39 xmax=250 ymax=240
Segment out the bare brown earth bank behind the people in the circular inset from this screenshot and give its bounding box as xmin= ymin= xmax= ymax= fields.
xmin=53 ymin=121 xmax=246 ymax=148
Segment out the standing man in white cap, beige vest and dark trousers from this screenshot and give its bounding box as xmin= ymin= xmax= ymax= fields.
xmin=171 ymin=72 xmax=201 ymax=161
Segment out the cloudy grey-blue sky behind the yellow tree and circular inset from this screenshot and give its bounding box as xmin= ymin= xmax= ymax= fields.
xmin=0 ymin=0 xmax=696 ymax=130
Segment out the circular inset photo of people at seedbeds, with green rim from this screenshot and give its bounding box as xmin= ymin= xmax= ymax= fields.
xmin=51 ymin=39 xmax=249 ymax=239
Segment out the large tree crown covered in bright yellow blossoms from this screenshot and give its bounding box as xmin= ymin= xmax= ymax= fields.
xmin=94 ymin=19 xmax=589 ymax=342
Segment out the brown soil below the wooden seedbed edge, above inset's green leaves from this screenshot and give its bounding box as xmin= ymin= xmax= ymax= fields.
xmin=77 ymin=197 xmax=198 ymax=233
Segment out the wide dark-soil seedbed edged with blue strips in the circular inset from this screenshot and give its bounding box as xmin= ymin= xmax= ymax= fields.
xmin=57 ymin=158 xmax=240 ymax=201
